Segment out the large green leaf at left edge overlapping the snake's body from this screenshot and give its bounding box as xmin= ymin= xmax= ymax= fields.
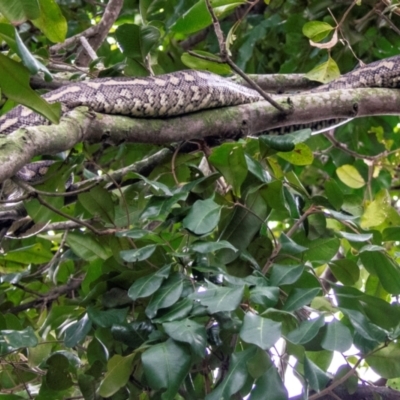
xmin=0 ymin=53 xmax=61 ymax=124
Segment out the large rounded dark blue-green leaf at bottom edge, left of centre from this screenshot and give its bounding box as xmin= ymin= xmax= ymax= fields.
xmin=142 ymin=339 xmax=191 ymax=399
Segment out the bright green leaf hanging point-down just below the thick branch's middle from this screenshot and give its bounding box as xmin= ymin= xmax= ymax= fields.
xmin=208 ymin=143 xmax=248 ymax=197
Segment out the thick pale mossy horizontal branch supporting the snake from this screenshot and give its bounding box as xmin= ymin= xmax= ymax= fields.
xmin=0 ymin=89 xmax=400 ymax=182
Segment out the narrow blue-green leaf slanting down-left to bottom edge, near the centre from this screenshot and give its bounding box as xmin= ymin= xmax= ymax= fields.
xmin=205 ymin=347 xmax=255 ymax=400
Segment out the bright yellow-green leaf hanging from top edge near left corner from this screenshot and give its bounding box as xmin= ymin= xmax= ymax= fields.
xmin=32 ymin=0 xmax=68 ymax=43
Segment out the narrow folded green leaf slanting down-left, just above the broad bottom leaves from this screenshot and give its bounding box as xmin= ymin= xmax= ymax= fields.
xmin=145 ymin=273 xmax=183 ymax=318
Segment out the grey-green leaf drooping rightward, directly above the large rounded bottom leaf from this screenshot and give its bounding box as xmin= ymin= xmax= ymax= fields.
xmin=163 ymin=318 xmax=207 ymax=358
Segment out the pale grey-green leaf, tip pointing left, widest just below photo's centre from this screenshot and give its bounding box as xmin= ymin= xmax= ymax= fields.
xmin=190 ymin=285 xmax=244 ymax=314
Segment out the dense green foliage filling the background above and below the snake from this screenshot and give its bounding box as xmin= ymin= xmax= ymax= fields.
xmin=0 ymin=0 xmax=400 ymax=400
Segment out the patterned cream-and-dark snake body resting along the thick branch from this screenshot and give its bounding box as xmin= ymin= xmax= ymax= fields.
xmin=0 ymin=56 xmax=400 ymax=180
